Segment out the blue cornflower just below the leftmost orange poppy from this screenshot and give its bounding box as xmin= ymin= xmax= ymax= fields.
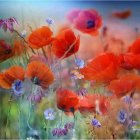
xmin=12 ymin=80 xmax=24 ymax=96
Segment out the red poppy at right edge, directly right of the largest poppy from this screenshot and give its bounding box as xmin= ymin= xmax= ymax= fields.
xmin=118 ymin=53 xmax=140 ymax=70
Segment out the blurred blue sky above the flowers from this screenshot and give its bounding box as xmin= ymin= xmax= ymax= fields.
xmin=0 ymin=0 xmax=140 ymax=38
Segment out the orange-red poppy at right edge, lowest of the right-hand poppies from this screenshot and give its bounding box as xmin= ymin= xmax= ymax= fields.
xmin=108 ymin=74 xmax=140 ymax=97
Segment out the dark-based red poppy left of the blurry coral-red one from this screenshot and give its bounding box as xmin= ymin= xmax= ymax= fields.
xmin=56 ymin=89 xmax=79 ymax=113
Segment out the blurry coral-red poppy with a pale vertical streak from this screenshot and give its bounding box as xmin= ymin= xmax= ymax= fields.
xmin=79 ymin=94 xmax=110 ymax=114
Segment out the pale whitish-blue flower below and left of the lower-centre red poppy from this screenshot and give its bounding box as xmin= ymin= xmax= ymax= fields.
xmin=44 ymin=108 xmax=55 ymax=120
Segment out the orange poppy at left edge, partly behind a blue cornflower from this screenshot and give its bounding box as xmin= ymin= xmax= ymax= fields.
xmin=0 ymin=66 xmax=25 ymax=89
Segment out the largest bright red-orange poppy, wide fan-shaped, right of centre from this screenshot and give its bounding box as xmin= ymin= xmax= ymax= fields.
xmin=80 ymin=53 xmax=118 ymax=83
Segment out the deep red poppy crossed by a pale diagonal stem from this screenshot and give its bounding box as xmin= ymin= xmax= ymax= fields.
xmin=52 ymin=29 xmax=80 ymax=58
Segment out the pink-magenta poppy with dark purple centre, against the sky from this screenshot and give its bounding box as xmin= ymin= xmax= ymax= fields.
xmin=67 ymin=9 xmax=102 ymax=36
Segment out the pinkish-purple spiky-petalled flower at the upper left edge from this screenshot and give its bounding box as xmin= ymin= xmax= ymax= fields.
xmin=0 ymin=17 xmax=18 ymax=32
